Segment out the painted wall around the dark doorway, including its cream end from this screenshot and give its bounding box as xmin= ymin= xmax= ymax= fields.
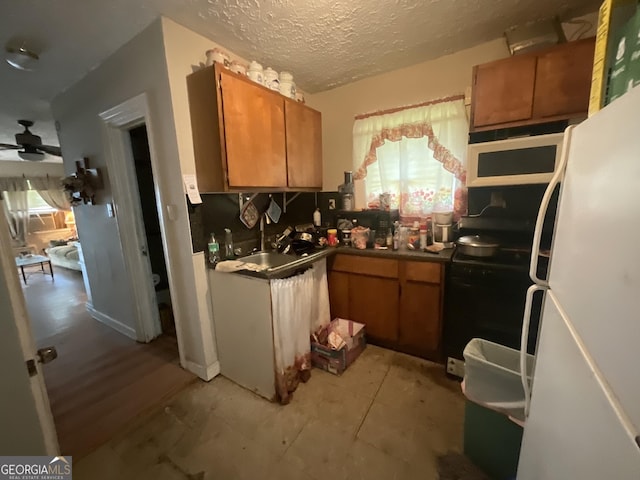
xmin=52 ymin=19 xmax=218 ymax=378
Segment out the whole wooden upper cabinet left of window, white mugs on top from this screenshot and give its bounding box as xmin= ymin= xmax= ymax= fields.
xmin=187 ymin=63 xmax=322 ymax=193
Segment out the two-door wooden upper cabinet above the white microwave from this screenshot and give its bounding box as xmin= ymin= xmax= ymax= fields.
xmin=470 ymin=38 xmax=595 ymax=131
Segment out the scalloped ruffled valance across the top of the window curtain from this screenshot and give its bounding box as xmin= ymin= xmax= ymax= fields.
xmin=353 ymin=95 xmax=469 ymax=184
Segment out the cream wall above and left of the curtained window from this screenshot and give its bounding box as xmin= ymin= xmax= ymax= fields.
xmin=307 ymin=12 xmax=597 ymax=190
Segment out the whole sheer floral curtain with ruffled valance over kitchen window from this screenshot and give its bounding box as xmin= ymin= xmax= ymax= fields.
xmin=353 ymin=95 xmax=469 ymax=219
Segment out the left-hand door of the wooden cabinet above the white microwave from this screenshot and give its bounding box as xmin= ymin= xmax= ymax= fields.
xmin=471 ymin=55 xmax=536 ymax=127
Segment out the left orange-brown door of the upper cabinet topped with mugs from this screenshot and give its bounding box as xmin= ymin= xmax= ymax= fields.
xmin=220 ymin=72 xmax=287 ymax=188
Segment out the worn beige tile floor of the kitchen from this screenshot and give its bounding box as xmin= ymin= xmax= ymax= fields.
xmin=74 ymin=345 xmax=464 ymax=480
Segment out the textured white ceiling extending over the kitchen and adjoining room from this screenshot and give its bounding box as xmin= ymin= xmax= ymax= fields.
xmin=0 ymin=0 xmax=600 ymax=159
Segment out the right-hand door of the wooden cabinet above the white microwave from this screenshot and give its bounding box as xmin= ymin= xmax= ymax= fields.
xmin=533 ymin=38 xmax=595 ymax=117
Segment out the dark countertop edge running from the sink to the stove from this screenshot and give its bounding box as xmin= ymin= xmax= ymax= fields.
xmin=218 ymin=247 xmax=453 ymax=280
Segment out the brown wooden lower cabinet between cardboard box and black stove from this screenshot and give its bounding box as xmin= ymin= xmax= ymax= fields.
xmin=328 ymin=254 xmax=444 ymax=361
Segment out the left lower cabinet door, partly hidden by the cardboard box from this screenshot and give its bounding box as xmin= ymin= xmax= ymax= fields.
xmin=349 ymin=274 xmax=398 ymax=345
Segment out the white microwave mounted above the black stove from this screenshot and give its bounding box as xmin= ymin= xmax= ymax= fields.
xmin=467 ymin=133 xmax=564 ymax=187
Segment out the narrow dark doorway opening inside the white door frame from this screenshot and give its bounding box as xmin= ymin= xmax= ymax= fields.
xmin=129 ymin=124 xmax=176 ymax=337
